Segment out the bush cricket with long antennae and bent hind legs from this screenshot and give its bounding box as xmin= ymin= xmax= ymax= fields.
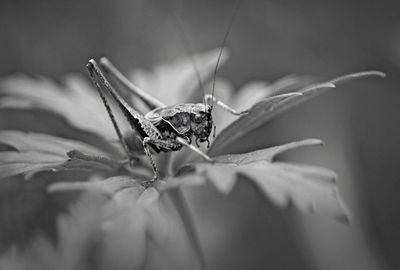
xmin=86 ymin=2 xmax=247 ymax=187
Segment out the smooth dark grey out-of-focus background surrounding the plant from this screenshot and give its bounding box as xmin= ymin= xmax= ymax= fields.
xmin=0 ymin=0 xmax=400 ymax=269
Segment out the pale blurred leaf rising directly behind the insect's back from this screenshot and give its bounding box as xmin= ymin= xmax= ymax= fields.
xmin=130 ymin=48 xmax=228 ymax=109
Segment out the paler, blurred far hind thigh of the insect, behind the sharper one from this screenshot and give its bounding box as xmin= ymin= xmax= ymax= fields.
xmin=100 ymin=57 xmax=166 ymax=110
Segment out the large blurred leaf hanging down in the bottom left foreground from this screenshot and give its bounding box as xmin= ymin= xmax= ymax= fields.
xmin=0 ymin=177 xmax=169 ymax=270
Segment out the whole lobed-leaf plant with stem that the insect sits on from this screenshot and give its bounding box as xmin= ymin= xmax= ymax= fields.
xmin=0 ymin=50 xmax=383 ymax=269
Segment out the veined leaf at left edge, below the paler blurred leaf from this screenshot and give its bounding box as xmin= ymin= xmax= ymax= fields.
xmin=0 ymin=130 xmax=115 ymax=178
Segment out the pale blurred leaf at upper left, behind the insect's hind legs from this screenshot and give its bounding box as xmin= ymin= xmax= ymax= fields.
xmin=0 ymin=75 xmax=116 ymax=139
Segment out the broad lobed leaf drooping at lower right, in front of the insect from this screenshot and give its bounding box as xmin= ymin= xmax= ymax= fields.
xmin=164 ymin=139 xmax=348 ymax=223
